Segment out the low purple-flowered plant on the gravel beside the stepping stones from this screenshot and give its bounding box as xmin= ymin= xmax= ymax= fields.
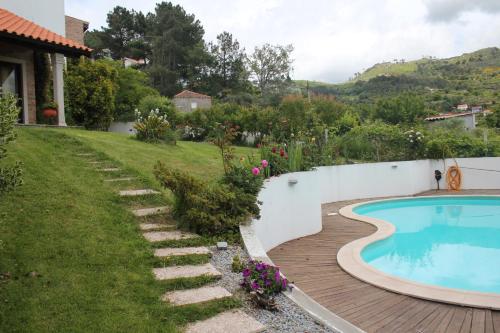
xmin=241 ymin=260 xmax=288 ymax=296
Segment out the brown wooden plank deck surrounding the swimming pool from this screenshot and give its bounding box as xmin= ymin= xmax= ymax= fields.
xmin=268 ymin=191 xmax=500 ymax=333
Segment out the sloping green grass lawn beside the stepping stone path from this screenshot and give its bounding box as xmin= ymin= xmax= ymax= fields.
xmin=0 ymin=128 xmax=252 ymax=332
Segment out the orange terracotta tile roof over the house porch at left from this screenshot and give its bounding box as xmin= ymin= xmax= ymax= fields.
xmin=0 ymin=8 xmax=92 ymax=53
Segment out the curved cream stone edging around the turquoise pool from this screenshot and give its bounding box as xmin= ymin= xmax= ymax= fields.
xmin=337 ymin=195 xmax=500 ymax=310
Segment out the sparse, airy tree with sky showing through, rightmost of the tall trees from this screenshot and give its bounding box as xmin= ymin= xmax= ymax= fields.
xmin=249 ymin=44 xmax=293 ymax=95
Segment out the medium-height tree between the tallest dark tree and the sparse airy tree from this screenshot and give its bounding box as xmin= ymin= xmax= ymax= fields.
xmin=203 ymin=31 xmax=248 ymax=97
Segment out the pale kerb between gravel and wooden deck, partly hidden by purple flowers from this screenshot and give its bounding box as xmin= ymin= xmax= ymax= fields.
xmin=240 ymin=222 xmax=364 ymax=333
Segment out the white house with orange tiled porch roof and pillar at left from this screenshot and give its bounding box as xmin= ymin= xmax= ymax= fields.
xmin=0 ymin=0 xmax=92 ymax=126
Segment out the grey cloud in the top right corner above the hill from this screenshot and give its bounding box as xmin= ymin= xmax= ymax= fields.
xmin=425 ymin=0 xmax=500 ymax=22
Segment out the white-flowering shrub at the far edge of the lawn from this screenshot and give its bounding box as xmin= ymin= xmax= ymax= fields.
xmin=134 ymin=109 xmax=175 ymax=143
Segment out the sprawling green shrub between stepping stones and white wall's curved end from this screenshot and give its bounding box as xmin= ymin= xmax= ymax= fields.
xmin=154 ymin=163 xmax=259 ymax=235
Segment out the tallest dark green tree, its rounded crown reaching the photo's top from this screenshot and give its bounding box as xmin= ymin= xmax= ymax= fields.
xmin=148 ymin=2 xmax=207 ymax=96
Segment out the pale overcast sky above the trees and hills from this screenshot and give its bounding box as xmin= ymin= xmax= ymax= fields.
xmin=66 ymin=0 xmax=500 ymax=83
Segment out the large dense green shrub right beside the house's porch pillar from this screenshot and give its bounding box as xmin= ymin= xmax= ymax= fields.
xmin=64 ymin=57 xmax=118 ymax=131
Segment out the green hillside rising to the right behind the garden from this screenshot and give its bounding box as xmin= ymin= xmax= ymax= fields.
xmin=295 ymin=47 xmax=500 ymax=111
